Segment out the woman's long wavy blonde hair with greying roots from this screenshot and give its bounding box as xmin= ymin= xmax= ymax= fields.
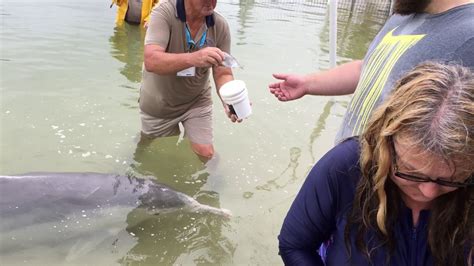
xmin=346 ymin=62 xmax=474 ymax=265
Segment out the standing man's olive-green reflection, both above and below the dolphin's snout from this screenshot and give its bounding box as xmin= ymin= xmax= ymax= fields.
xmin=120 ymin=137 xmax=236 ymax=265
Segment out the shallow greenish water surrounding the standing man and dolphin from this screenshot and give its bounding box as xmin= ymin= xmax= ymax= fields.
xmin=0 ymin=0 xmax=388 ymax=265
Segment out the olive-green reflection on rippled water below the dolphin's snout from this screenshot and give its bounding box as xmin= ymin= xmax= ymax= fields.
xmin=120 ymin=210 xmax=236 ymax=265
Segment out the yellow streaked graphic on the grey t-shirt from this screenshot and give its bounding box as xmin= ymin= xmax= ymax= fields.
xmin=348 ymin=29 xmax=425 ymax=136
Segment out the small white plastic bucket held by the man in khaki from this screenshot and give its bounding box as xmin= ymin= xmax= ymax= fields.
xmin=219 ymin=80 xmax=252 ymax=118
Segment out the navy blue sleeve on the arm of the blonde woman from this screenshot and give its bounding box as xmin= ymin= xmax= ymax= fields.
xmin=278 ymin=141 xmax=358 ymax=265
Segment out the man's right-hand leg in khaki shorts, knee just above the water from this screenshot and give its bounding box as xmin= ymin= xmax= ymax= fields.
xmin=182 ymin=105 xmax=214 ymax=160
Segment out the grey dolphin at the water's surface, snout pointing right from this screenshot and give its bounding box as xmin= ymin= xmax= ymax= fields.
xmin=0 ymin=173 xmax=230 ymax=232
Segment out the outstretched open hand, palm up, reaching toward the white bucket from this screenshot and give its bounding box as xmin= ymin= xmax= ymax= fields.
xmin=268 ymin=74 xmax=307 ymax=102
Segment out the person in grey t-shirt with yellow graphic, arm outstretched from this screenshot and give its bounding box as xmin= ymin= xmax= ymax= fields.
xmin=269 ymin=0 xmax=474 ymax=142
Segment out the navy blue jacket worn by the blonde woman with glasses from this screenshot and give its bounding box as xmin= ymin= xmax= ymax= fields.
xmin=278 ymin=139 xmax=440 ymax=266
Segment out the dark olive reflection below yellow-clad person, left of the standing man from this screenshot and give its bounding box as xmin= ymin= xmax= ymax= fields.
xmin=109 ymin=23 xmax=146 ymax=83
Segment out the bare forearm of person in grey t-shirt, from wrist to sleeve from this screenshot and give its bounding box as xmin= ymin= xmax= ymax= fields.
xmin=306 ymin=60 xmax=362 ymax=95
